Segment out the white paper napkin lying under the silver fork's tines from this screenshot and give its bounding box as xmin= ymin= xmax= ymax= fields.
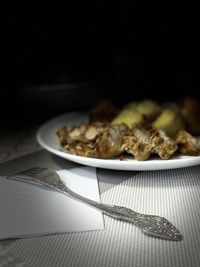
xmin=0 ymin=167 xmax=104 ymax=239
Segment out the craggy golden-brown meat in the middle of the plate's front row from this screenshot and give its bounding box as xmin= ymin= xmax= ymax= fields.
xmin=123 ymin=127 xmax=177 ymax=160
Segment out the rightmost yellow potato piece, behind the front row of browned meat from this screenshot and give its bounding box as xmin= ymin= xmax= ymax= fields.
xmin=152 ymin=107 xmax=185 ymax=137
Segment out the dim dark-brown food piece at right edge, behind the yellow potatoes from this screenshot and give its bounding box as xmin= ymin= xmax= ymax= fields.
xmin=179 ymin=97 xmax=200 ymax=135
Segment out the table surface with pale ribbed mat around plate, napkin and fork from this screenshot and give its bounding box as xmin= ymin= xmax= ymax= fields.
xmin=0 ymin=127 xmax=200 ymax=267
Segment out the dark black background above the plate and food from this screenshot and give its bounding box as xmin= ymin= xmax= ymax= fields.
xmin=1 ymin=11 xmax=200 ymax=126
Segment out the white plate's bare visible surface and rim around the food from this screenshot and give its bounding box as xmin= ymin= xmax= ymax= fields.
xmin=37 ymin=112 xmax=200 ymax=171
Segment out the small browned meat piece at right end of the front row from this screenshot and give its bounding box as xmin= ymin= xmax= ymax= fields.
xmin=176 ymin=130 xmax=200 ymax=156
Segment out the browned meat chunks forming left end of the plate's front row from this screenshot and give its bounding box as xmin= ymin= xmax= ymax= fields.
xmin=57 ymin=123 xmax=128 ymax=158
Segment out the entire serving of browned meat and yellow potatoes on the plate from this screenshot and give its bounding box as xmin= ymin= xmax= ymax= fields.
xmin=56 ymin=100 xmax=200 ymax=161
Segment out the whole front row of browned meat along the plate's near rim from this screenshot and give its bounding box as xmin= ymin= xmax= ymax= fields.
xmin=57 ymin=123 xmax=200 ymax=161
